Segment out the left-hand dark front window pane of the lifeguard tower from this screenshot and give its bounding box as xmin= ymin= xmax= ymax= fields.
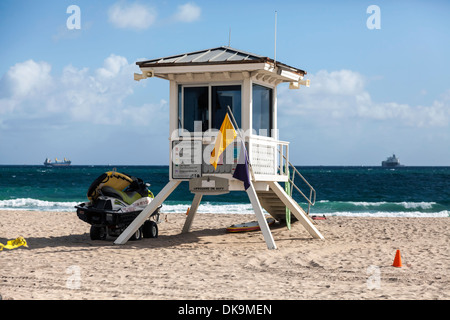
xmin=183 ymin=87 xmax=209 ymax=132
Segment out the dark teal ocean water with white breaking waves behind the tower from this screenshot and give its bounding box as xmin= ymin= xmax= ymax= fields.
xmin=0 ymin=165 xmax=450 ymax=217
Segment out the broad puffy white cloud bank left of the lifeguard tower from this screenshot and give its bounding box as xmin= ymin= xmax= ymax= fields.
xmin=0 ymin=54 xmax=168 ymax=129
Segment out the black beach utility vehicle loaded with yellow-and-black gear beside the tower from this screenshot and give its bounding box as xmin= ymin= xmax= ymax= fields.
xmin=75 ymin=171 xmax=162 ymax=240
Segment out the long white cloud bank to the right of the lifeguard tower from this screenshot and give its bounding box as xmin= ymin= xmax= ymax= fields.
xmin=278 ymin=70 xmax=450 ymax=127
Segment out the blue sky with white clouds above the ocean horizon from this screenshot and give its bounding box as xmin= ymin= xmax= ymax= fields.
xmin=0 ymin=0 xmax=450 ymax=166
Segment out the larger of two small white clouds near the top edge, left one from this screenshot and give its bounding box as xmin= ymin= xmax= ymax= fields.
xmin=108 ymin=2 xmax=157 ymax=30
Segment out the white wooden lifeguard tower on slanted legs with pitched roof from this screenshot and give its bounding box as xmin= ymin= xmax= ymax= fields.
xmin=115 ymin=47 xmax=323 ymax=249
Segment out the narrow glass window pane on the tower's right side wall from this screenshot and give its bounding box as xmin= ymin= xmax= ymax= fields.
xmin=252 ymin=84 xmax=272 ymax=137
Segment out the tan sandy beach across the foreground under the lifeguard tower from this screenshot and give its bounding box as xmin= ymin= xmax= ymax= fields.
xmin=0 ymin=211 xmax=450 ymax=300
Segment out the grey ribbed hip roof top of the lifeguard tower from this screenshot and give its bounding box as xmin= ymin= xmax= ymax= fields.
xmin=136 ymin=46 xmax=306 ymax=75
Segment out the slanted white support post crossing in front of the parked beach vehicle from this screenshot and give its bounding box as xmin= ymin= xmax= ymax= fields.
xmin=114 ymin=180 xmax=181 ymax=244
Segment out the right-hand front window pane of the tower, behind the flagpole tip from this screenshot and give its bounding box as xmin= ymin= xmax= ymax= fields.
xmin=211 ymin=85 xmax=241 ymax=129
